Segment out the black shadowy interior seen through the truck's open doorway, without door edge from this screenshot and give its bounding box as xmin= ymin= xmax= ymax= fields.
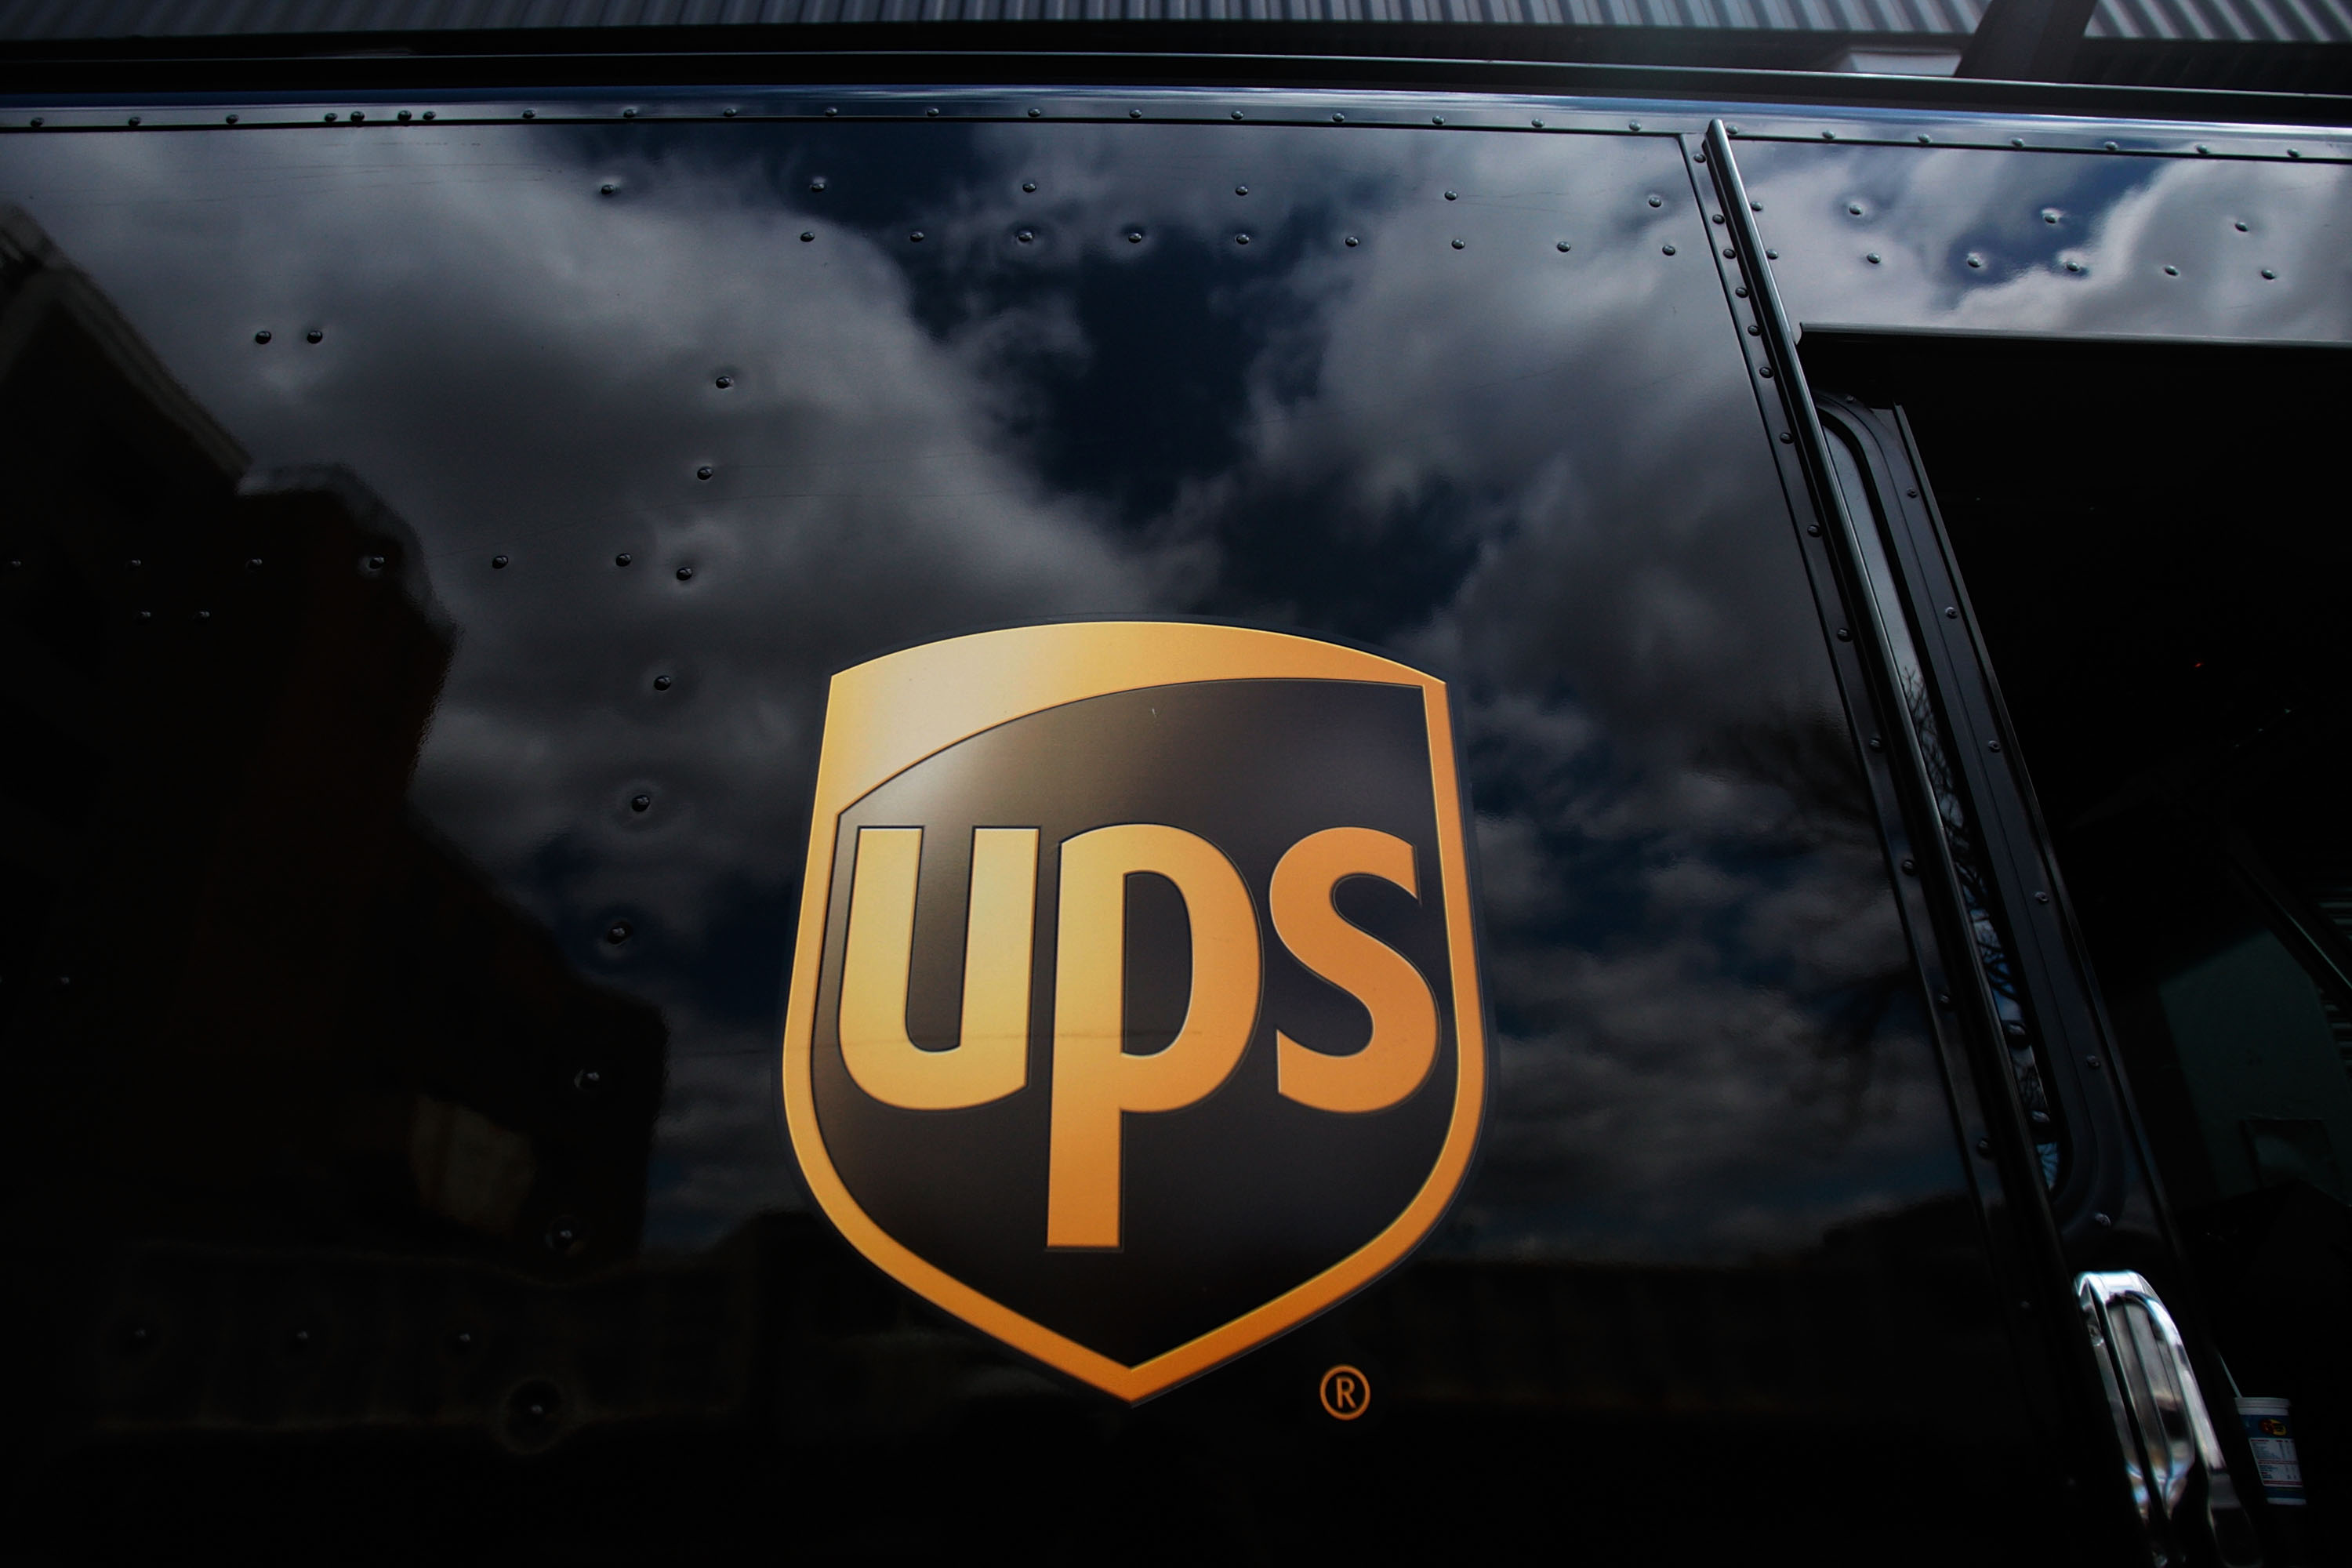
xmin=1806 ymin=341 xmax=2352 ymax=1556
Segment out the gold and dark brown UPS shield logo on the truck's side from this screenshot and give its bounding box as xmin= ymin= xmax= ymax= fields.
xmin=783 ymin=621 xmax=1486 ymax=1399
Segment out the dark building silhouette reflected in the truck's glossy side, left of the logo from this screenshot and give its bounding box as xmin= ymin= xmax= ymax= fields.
xmin=0 ymin=214 xmax=666 ymax=1429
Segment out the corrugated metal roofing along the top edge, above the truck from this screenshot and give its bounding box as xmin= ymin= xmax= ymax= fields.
xmin=0 ymin=0 xmax=2352 ymax=42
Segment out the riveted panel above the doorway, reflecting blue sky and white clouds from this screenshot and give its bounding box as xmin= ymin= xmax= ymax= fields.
xmin=1740 ymin=143 xmax=2352 ymax=343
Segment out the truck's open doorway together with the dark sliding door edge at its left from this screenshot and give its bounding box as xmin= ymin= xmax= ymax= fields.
xmin=1804 ymin=334 xmax=2352 ymax=1561
